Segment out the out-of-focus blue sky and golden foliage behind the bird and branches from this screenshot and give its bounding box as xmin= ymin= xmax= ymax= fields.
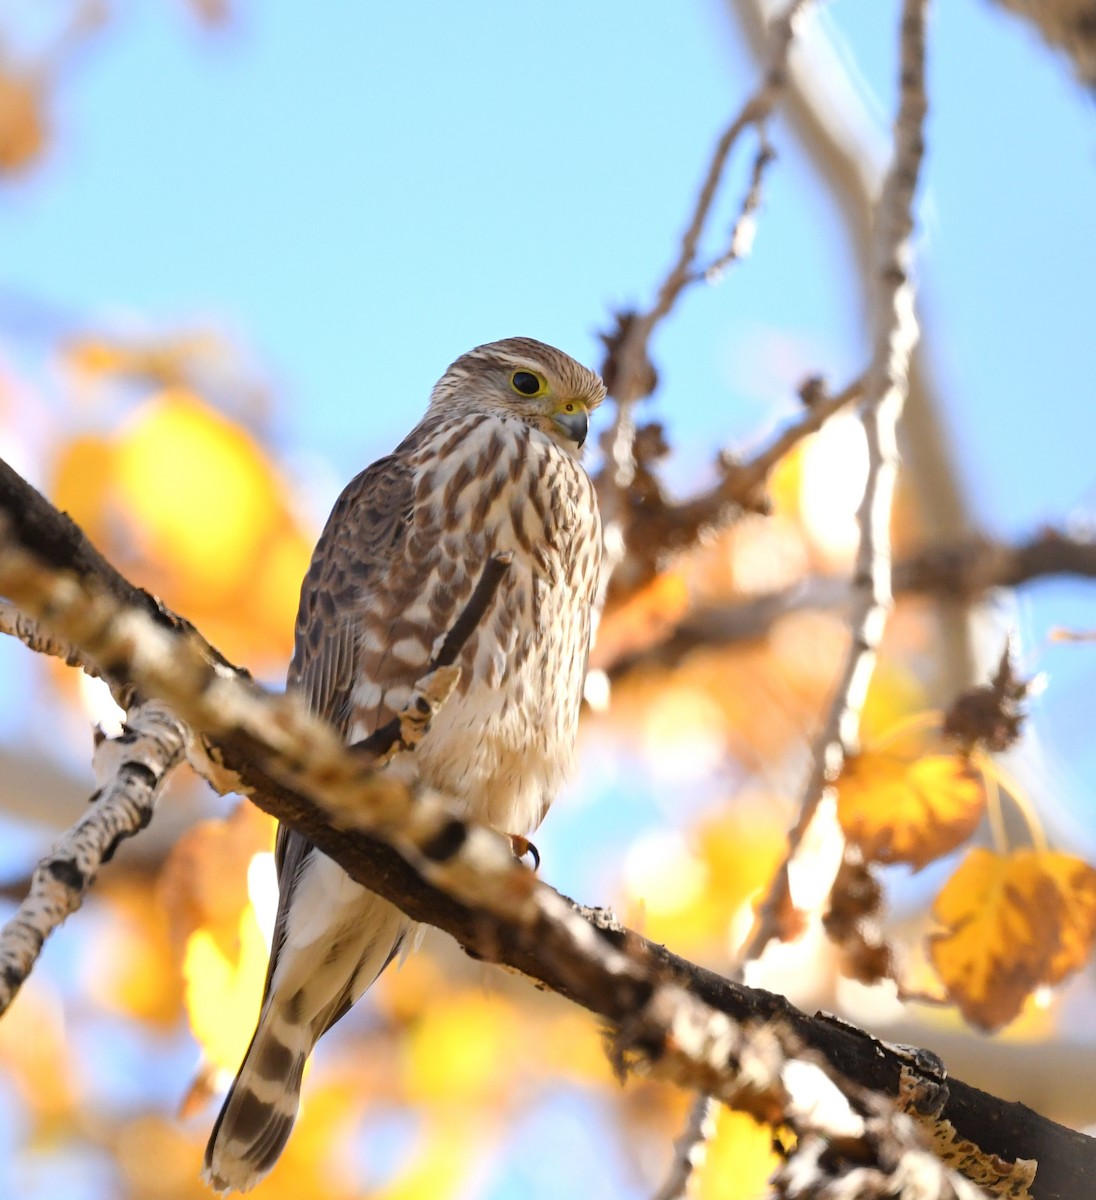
xmin=0 ymin=0 xmax=1096 ymax=1200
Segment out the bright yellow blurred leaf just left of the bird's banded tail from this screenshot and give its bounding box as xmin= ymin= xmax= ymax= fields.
xmin=182 ymin=907 xmax=268 ymax=1072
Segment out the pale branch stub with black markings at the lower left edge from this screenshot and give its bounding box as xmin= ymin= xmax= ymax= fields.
xmin=0 ymin=702 xmax=186 ymax=1015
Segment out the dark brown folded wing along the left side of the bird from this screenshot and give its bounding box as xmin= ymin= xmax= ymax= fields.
xmin=266 ymin=456 xmax=414 ymax=955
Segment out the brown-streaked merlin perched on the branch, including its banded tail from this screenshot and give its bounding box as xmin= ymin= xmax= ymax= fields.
xmin=204 ymin=337 xmax=605 ymax=1192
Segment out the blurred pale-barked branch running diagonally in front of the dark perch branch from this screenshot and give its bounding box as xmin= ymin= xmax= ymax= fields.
xmin=0 ymin=513 xmax=1008 ymax=1200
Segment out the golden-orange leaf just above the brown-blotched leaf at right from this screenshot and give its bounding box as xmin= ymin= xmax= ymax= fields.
xmin=837 ymin=750 xmax=986 ymax=870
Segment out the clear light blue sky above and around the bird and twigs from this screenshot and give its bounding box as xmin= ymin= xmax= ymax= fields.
xmin=0 ymin=0 xmax=1096 ymax=1190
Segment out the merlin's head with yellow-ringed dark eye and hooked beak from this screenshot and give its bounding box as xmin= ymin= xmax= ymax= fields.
xmin=430 ymin=337 xmax=605 ymax=454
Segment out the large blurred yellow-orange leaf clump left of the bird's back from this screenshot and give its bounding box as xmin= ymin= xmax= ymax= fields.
xmin=53 ymin=388 xmax=313 ymax=666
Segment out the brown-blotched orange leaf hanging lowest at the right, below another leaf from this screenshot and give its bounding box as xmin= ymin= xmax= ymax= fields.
xmin=928 ymin=848 xmax=1064 ymax=1030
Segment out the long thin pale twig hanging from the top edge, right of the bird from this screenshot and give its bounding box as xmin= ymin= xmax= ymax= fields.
xmin=742 ymin=0 xmax=928 ymax=961
